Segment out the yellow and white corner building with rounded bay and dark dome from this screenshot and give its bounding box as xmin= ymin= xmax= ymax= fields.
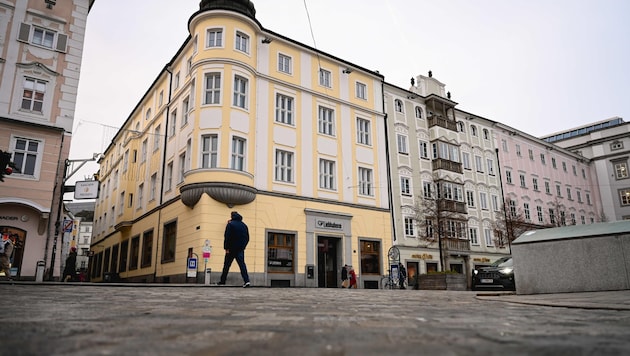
xmin=90 ymin=0 xmax=392 ymax=288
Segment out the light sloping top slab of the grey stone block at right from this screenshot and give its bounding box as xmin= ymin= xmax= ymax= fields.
xmin=512 ymin=220 xmax=630 ymax=245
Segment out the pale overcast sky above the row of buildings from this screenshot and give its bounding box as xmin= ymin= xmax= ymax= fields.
xmin=70 ymin=0 xmax=630 ymax=186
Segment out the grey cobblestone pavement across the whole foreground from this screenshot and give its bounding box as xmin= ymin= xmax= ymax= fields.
xmin=0 ymin=283 xmax=630 ymax=356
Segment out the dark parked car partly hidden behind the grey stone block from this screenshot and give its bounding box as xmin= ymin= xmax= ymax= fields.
xmin=472 ymin=256 xmax=516 ymax=290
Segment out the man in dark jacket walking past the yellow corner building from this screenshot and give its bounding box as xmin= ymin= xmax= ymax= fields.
xmin=217 ymin=211 xmax=250 ymax=288
